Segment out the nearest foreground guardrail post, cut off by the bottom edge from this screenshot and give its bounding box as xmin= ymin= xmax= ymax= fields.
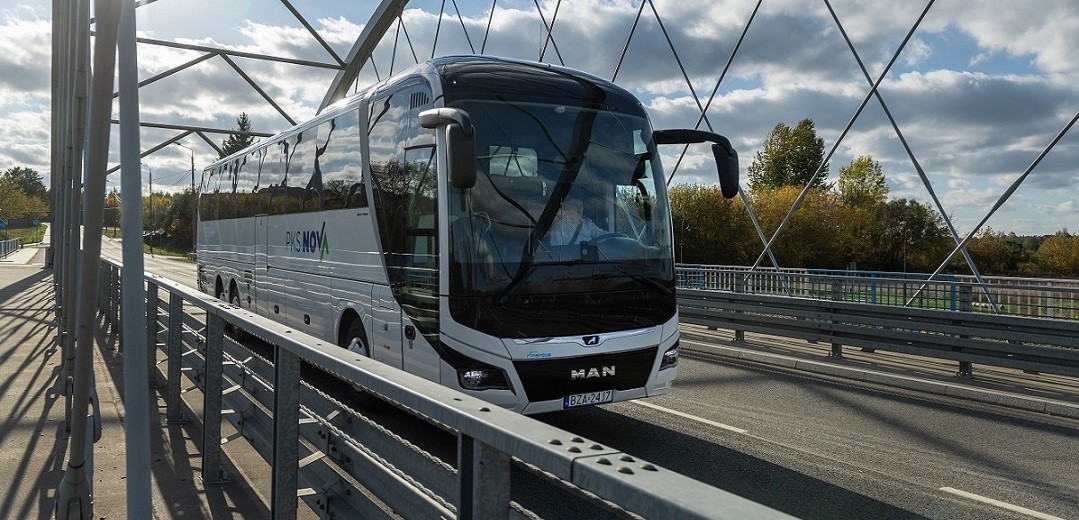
xmin=457 ymin=434 xmax=510 ymax=520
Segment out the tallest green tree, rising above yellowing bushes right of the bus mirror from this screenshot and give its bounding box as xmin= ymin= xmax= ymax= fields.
xmin=748 ymin=118 xmax=829 ymax=191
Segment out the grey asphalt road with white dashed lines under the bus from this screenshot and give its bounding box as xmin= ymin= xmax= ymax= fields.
xmin=111 ymin=240 xmax=1079 ymax=520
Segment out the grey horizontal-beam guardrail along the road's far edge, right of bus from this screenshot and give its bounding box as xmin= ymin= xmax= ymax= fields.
xmin=678 ymin=286 xmax=1079 ymax=375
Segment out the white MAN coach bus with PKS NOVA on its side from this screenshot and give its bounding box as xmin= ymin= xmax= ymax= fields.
xmin=197 ymin=56 xmax=738 ymax=413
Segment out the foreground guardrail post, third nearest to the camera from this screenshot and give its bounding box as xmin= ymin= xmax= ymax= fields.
xmin=203 ymin=312 xmax=229 ymax=483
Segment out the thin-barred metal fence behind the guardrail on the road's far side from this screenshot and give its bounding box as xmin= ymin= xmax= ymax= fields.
xmin=677 ymin=264 xmax=1079 ymax=319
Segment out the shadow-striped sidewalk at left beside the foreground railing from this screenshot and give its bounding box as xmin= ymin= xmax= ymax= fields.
xmin=0 ymin=266 xmax=268 ymax=520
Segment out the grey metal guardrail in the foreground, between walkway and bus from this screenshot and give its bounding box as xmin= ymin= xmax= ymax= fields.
xmin=99 ymin=262 xmax=792 ymax=519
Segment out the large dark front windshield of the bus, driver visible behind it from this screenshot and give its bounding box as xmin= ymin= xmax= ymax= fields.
xmin=450 ymin=99 xmax=673 ymax=337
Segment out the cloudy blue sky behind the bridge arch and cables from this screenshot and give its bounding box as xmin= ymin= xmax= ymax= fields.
xmin=0 ymin=0 xmax=1079 ymax=235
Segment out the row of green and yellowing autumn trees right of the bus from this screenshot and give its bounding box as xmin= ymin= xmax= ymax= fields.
xmin=670 ymin=119 xmax=1079 ymax=278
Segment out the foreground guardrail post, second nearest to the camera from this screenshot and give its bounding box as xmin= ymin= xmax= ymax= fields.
xmin=270 ymin=346 xmax=302 ymax=520
